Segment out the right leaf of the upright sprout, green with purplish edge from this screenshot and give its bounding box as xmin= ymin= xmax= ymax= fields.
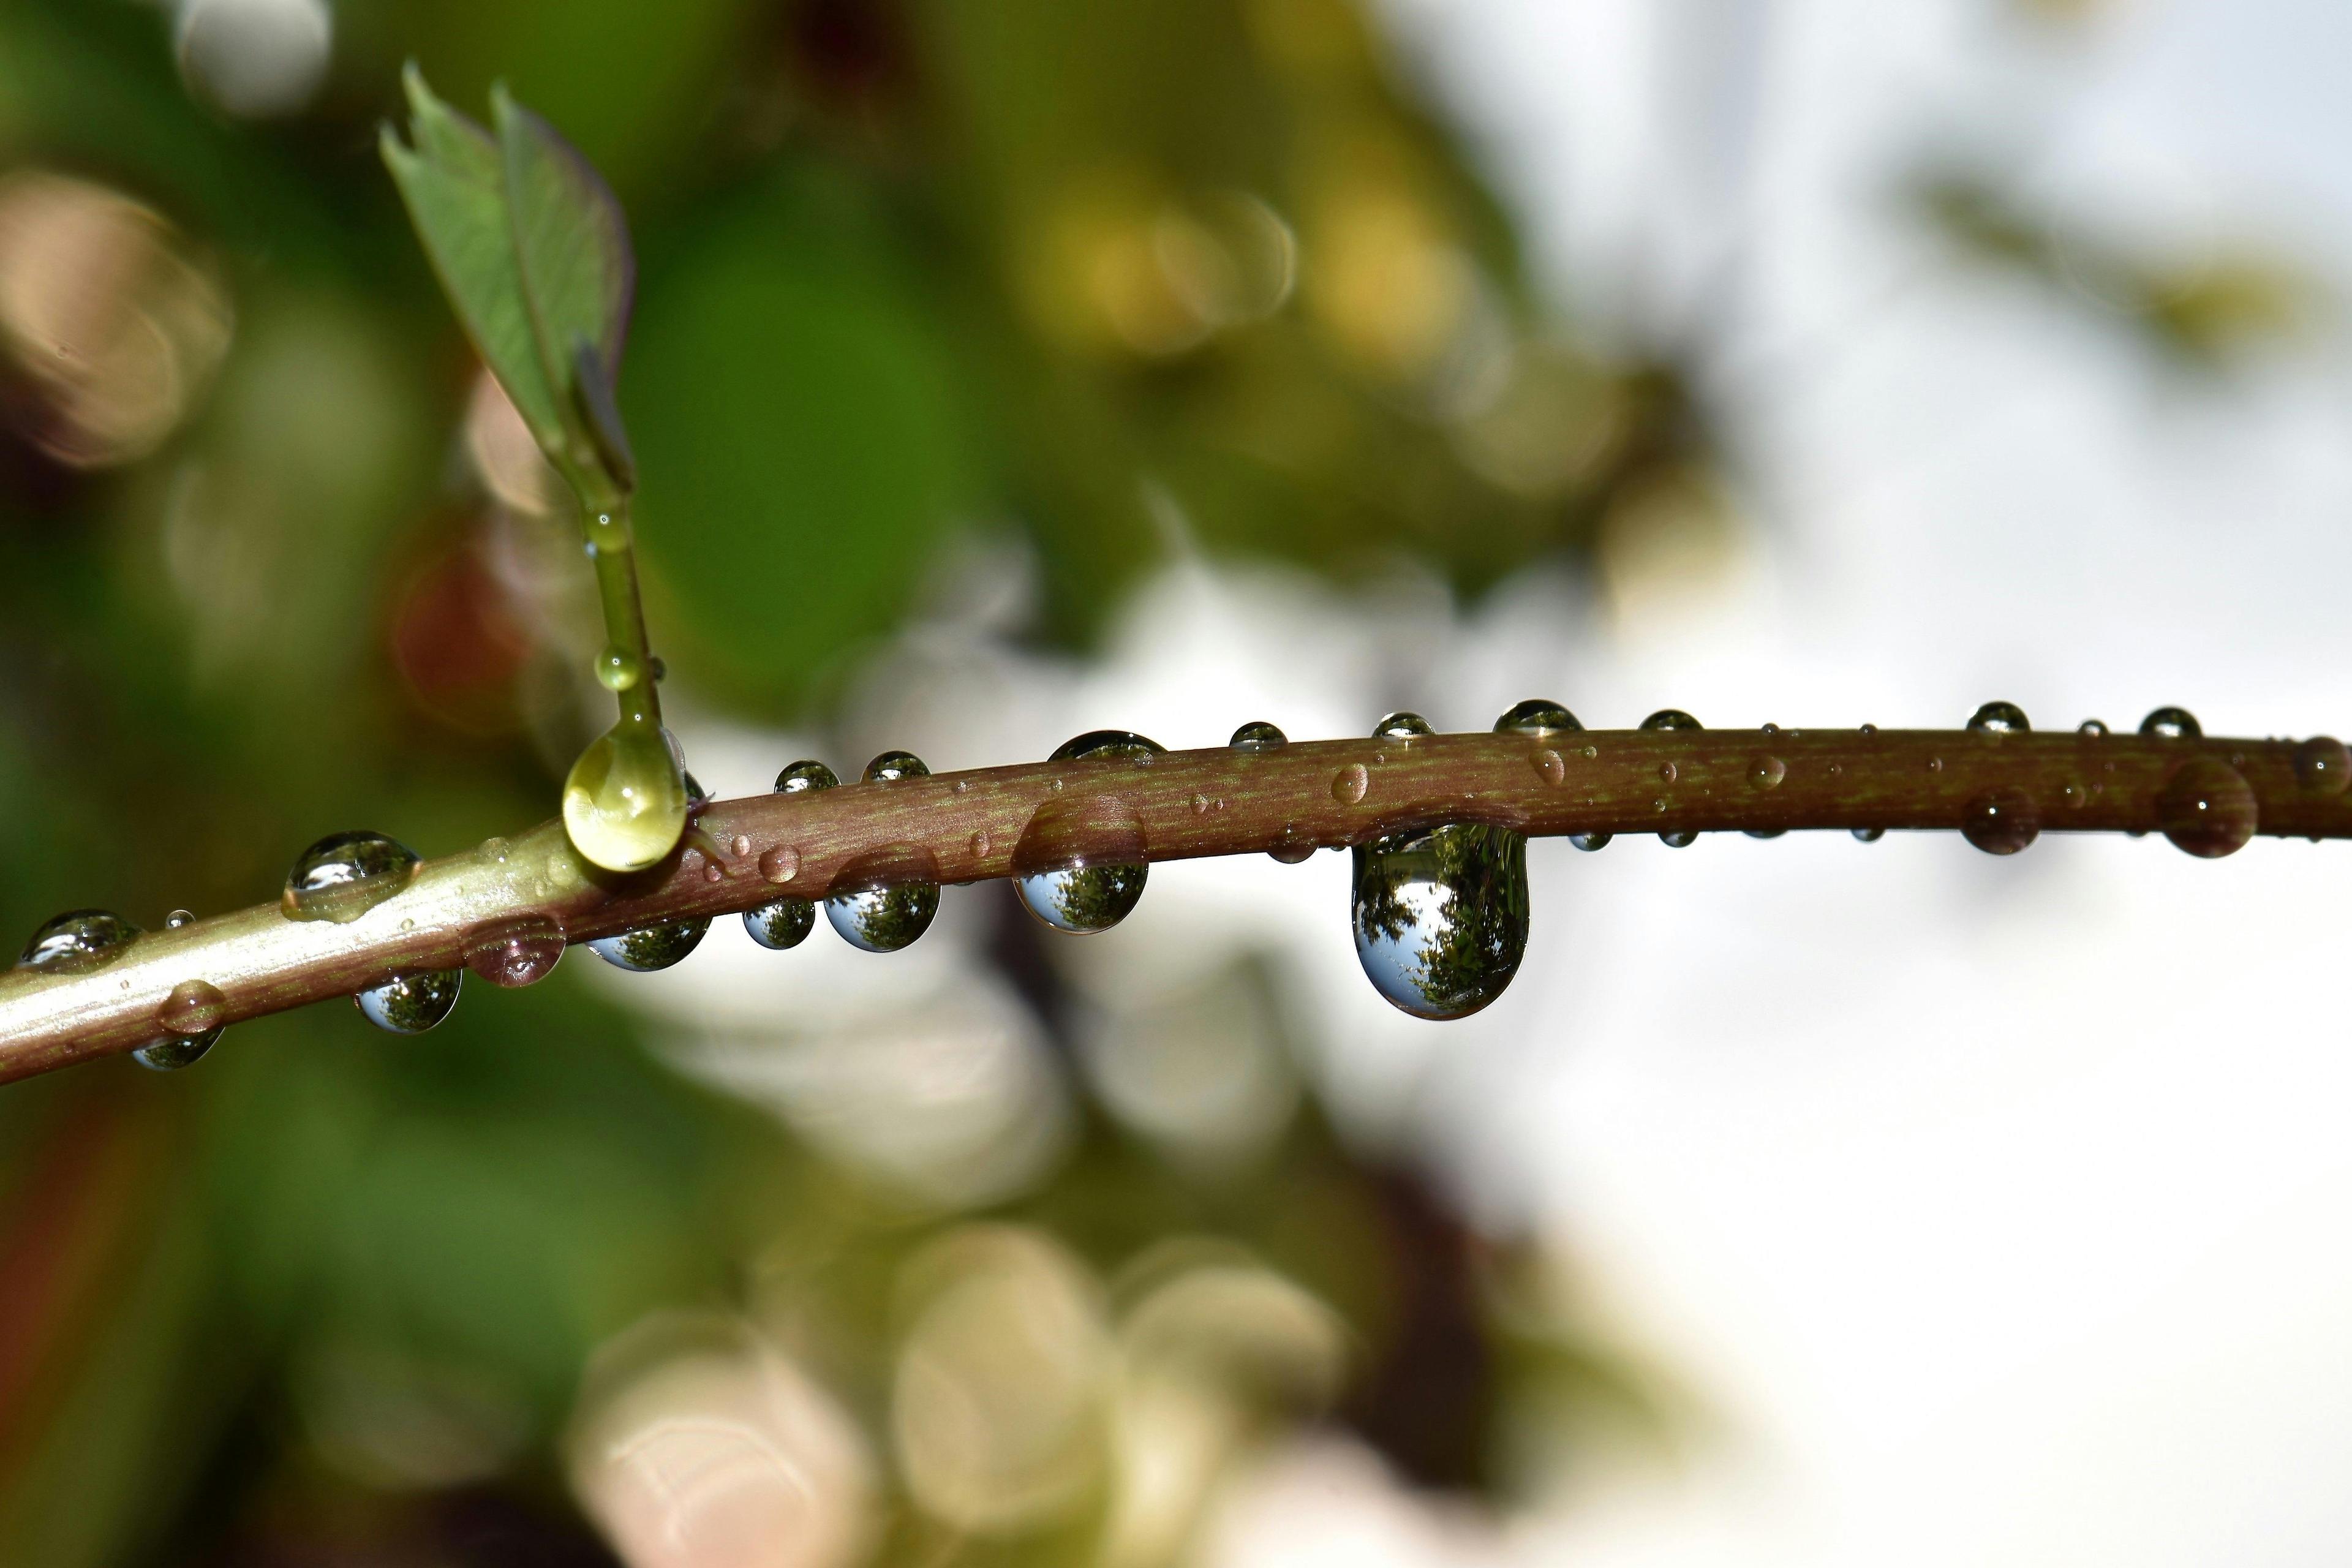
xmin=489 ymin=87 xmax=638 ymax=482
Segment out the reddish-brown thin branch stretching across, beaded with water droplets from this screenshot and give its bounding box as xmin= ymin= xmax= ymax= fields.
xmin=0 ymin=729 xmax=2352 ymax=1082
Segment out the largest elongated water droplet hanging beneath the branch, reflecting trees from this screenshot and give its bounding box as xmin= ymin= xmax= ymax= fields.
xmin=1352 ymin=823 xmax=1529 ymax=1018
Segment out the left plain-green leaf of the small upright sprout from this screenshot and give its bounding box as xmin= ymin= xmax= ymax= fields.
xmin=383 ymin=66 xmax=567 ymax=466
